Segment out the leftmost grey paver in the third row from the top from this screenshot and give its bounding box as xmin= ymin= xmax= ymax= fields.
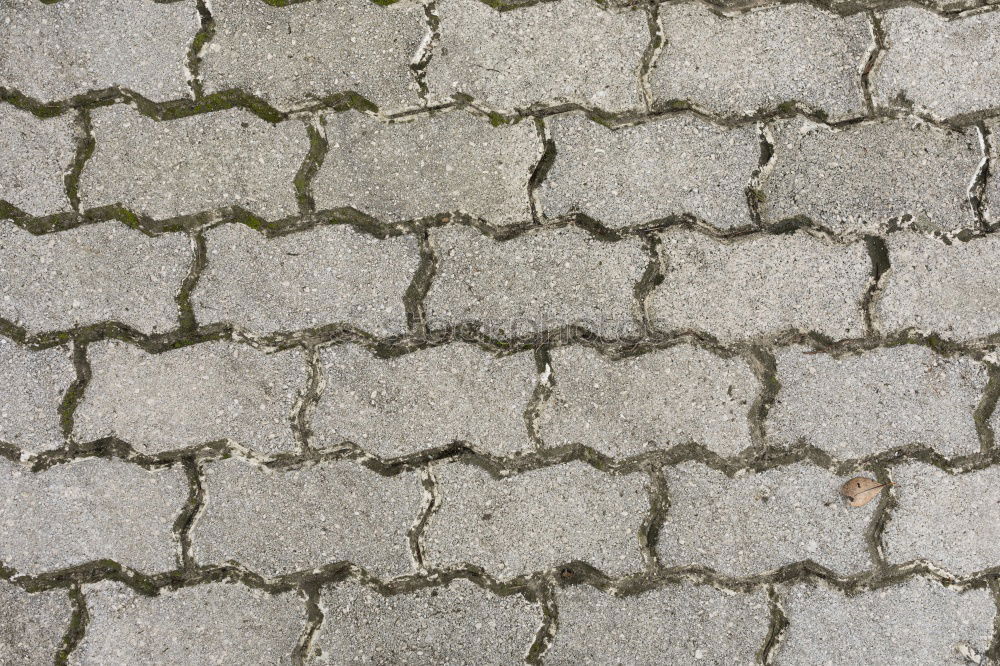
xmin=0 ymin=220 xmax=191 ymax=333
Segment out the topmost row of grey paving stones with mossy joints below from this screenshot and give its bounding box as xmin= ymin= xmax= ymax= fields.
xmin=0 ymin=0 xmax=1000 ymax=120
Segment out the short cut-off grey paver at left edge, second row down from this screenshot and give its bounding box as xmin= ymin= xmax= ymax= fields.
xmin=0 ymin=106 xmax=76 ymax=215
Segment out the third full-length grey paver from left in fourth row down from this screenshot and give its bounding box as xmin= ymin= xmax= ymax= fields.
xmin=537 ymin=345 xmax=760 ymax=457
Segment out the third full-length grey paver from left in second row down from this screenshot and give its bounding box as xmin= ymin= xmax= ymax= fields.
xmin=538 ymin=114 xmax=760 ymax=229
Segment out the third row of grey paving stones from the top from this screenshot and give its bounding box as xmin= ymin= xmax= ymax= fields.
xmin=9 ymin=221 xmax=1000 ymax=343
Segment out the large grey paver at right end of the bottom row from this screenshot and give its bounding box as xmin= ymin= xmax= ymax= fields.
xmin=774 ymin=578 xmax=996 ymax=665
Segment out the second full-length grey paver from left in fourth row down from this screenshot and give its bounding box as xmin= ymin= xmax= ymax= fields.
xmin=311 ymin=343 xmax=538 ymax=458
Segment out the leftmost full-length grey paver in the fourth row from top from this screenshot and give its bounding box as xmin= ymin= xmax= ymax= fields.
xmin=73 ymin=341 xmax=307 ymax=455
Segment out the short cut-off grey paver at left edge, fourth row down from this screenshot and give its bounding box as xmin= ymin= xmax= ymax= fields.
xmin=0 ymin=336 xmax=76 ymax=453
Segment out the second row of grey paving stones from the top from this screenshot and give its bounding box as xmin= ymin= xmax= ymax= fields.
xmin=0 ymin=101 xmax=1000 ymax=232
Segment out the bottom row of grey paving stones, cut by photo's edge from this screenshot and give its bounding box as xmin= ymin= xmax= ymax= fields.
xmin=0 ymin=578 xmax=996 ymax=665
